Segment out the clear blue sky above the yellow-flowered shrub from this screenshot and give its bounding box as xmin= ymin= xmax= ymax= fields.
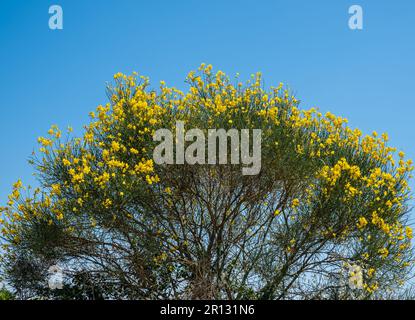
xmin=0 ymin=0 xmax=415 ymax=208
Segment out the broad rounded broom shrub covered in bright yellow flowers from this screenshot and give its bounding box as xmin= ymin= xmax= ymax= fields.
xmin=2 ymin=65 xmax=413 ymax=299
